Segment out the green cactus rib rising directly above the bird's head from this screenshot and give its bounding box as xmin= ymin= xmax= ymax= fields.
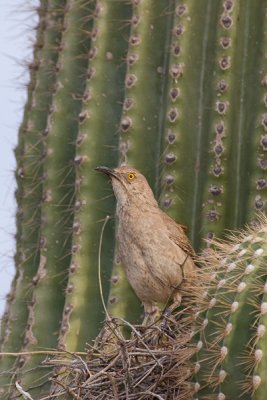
xmin=120 ymin=0 xmax=174 ymax=190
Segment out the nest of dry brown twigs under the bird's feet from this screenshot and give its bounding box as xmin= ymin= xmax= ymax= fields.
xmin=49 ymin=299 xmax=199 ymax=400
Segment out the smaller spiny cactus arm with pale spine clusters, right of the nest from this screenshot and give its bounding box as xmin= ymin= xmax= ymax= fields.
xmin=194 ymin=220 xmax=267 ymax=400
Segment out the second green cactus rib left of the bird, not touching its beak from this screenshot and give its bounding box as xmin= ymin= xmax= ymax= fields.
xmin=17 ymin=0 xmax=93 ymax=393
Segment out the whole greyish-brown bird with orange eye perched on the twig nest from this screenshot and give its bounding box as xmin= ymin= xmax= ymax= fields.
xmin=96 ymin=166 xmax=196 ymax=315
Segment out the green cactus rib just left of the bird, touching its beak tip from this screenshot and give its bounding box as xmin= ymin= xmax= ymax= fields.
xmin=60 ymin=0 xmax=131 ymax=351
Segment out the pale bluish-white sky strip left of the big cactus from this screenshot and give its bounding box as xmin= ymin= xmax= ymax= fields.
xmin=0 ymin=0 xmax=37 ymax=315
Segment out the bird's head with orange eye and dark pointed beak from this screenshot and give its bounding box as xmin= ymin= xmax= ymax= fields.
xmin=96 ymin=166 xmax=157 ymax=207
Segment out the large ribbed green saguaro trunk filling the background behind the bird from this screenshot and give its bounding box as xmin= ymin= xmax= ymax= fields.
xmin=0 ymin=0 xmax=267 ymax=396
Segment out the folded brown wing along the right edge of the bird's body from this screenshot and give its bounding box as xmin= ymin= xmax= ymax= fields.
xmin=162 ymin=212 xmax=195 ymax=256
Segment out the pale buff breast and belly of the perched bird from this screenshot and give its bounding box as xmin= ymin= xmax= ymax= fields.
xmin=117 ymin=206 xmax=185 ymax=301
